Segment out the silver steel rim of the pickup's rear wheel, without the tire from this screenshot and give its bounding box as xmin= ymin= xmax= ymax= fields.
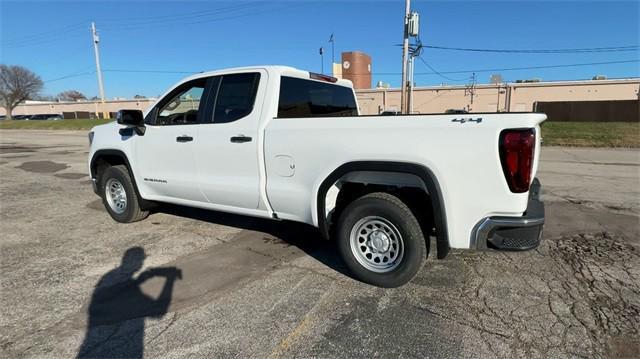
xmin=349 ymin=216 xmax=404 ymax=273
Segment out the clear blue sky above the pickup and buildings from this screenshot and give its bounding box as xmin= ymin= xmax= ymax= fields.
xmin=0 ymin=0 xmax=640 ymax=98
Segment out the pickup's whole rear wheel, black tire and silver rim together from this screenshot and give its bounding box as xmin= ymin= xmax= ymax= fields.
xmin=337 ymin=192 xmax=427 ymax=287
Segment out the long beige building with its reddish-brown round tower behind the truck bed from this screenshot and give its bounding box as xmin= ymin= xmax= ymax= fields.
xmin=333 ymin=51 xmax=640 ymax=121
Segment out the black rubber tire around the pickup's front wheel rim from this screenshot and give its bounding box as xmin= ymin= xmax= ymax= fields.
xmin=100 ymin=165 xmax=149 ymax=223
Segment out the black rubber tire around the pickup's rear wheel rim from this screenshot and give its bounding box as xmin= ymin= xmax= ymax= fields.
xmin=336 ymin=192 xmax=427 ymax=288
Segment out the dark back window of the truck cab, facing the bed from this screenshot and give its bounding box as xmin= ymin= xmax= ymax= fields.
xmin=278 ymin=76 xmax=358 ymax=118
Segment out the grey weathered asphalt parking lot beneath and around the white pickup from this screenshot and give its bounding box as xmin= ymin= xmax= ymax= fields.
xmin=0 ymin=130 xmax=640 ymax=358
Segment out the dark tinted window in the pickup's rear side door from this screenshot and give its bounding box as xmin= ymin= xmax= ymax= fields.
xmin=212 ymin=72 xmax=260 ymax=123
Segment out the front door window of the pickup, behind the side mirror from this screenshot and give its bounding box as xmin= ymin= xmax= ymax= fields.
xmin=154 ymin=78 xmax=207 ymax=126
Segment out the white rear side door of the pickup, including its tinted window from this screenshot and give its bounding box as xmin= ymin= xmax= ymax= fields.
xmin=195 ymin=71 xmax=267 ymax=209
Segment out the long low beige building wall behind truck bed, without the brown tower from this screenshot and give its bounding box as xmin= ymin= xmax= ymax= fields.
xmin=357 ymin=78 xmax=640 ymax=121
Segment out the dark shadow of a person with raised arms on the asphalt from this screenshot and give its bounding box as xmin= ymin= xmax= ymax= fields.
xmin=78 ymin=247 xmax=182 ymax=358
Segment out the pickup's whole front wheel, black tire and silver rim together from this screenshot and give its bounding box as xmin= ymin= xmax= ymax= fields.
xmin=101 ymin=165 xmax=149 ymax=223
